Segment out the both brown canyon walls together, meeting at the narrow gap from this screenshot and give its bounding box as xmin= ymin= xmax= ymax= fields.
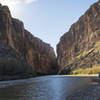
xmin=0 ymin=1 xmax=100 ymax=80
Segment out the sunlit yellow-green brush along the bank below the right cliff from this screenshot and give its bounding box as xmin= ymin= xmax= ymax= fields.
xmin=72 ymin=66 xmax=100 ymax=74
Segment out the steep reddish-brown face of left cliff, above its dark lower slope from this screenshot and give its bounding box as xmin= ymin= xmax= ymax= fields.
xmin=0 ymin=4 xmax=57 ymax=79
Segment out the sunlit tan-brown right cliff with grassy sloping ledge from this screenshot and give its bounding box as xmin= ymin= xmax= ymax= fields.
xmin=57 ymin=0 xmax=100 ymax=73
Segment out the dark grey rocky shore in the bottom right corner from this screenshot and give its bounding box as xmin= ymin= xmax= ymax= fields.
xmin=66 ymin=82 xmax=100 ymax=100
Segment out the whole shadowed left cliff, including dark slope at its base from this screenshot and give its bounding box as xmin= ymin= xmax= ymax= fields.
xmin=0 ymin=4 xmax=57 ymax=79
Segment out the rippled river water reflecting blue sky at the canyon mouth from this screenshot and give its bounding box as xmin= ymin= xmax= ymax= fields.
xmin=0 ymin=76 xmax=91 ymax=100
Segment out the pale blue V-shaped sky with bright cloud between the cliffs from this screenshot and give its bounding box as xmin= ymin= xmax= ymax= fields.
xmin=0 ymin=0 xmax=98 ymax=51
